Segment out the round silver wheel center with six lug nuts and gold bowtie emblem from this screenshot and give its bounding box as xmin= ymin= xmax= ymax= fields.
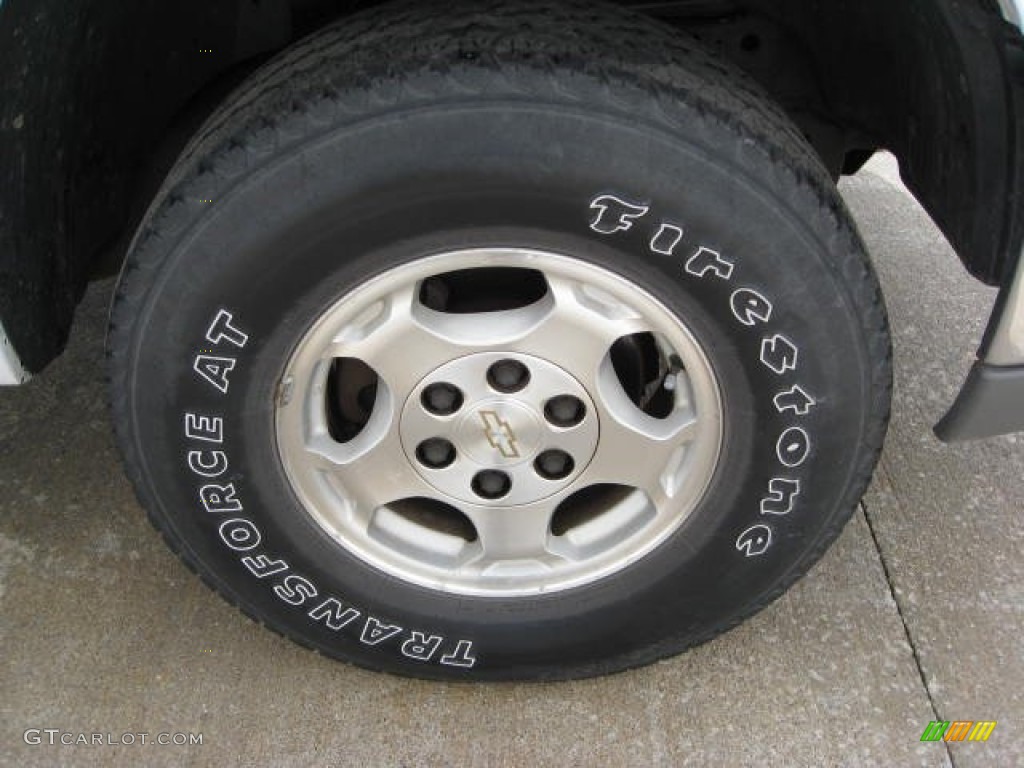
xmin=400 ymin=352 xmax=600 ymax=507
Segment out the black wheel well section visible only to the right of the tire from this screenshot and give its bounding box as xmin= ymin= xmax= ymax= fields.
xmin=638 ymin=0 xmax=1024 ymax=284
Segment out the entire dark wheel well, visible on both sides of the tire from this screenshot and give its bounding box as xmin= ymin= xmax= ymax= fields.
xmin=0 ymin=0 xmax=1024 ymax=372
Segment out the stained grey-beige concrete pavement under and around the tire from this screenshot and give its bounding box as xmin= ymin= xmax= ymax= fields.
xmin=0 ymin=158 xmax=1024 ymax=768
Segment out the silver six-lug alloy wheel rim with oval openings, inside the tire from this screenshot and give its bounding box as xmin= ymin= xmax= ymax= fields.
xmin=275 ymin=249 xmax=722 ymax=596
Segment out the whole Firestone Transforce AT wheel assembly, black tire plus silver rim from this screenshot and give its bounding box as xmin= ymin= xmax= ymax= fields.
xmin=110 ymin=2 xmax=891 ymax=680
